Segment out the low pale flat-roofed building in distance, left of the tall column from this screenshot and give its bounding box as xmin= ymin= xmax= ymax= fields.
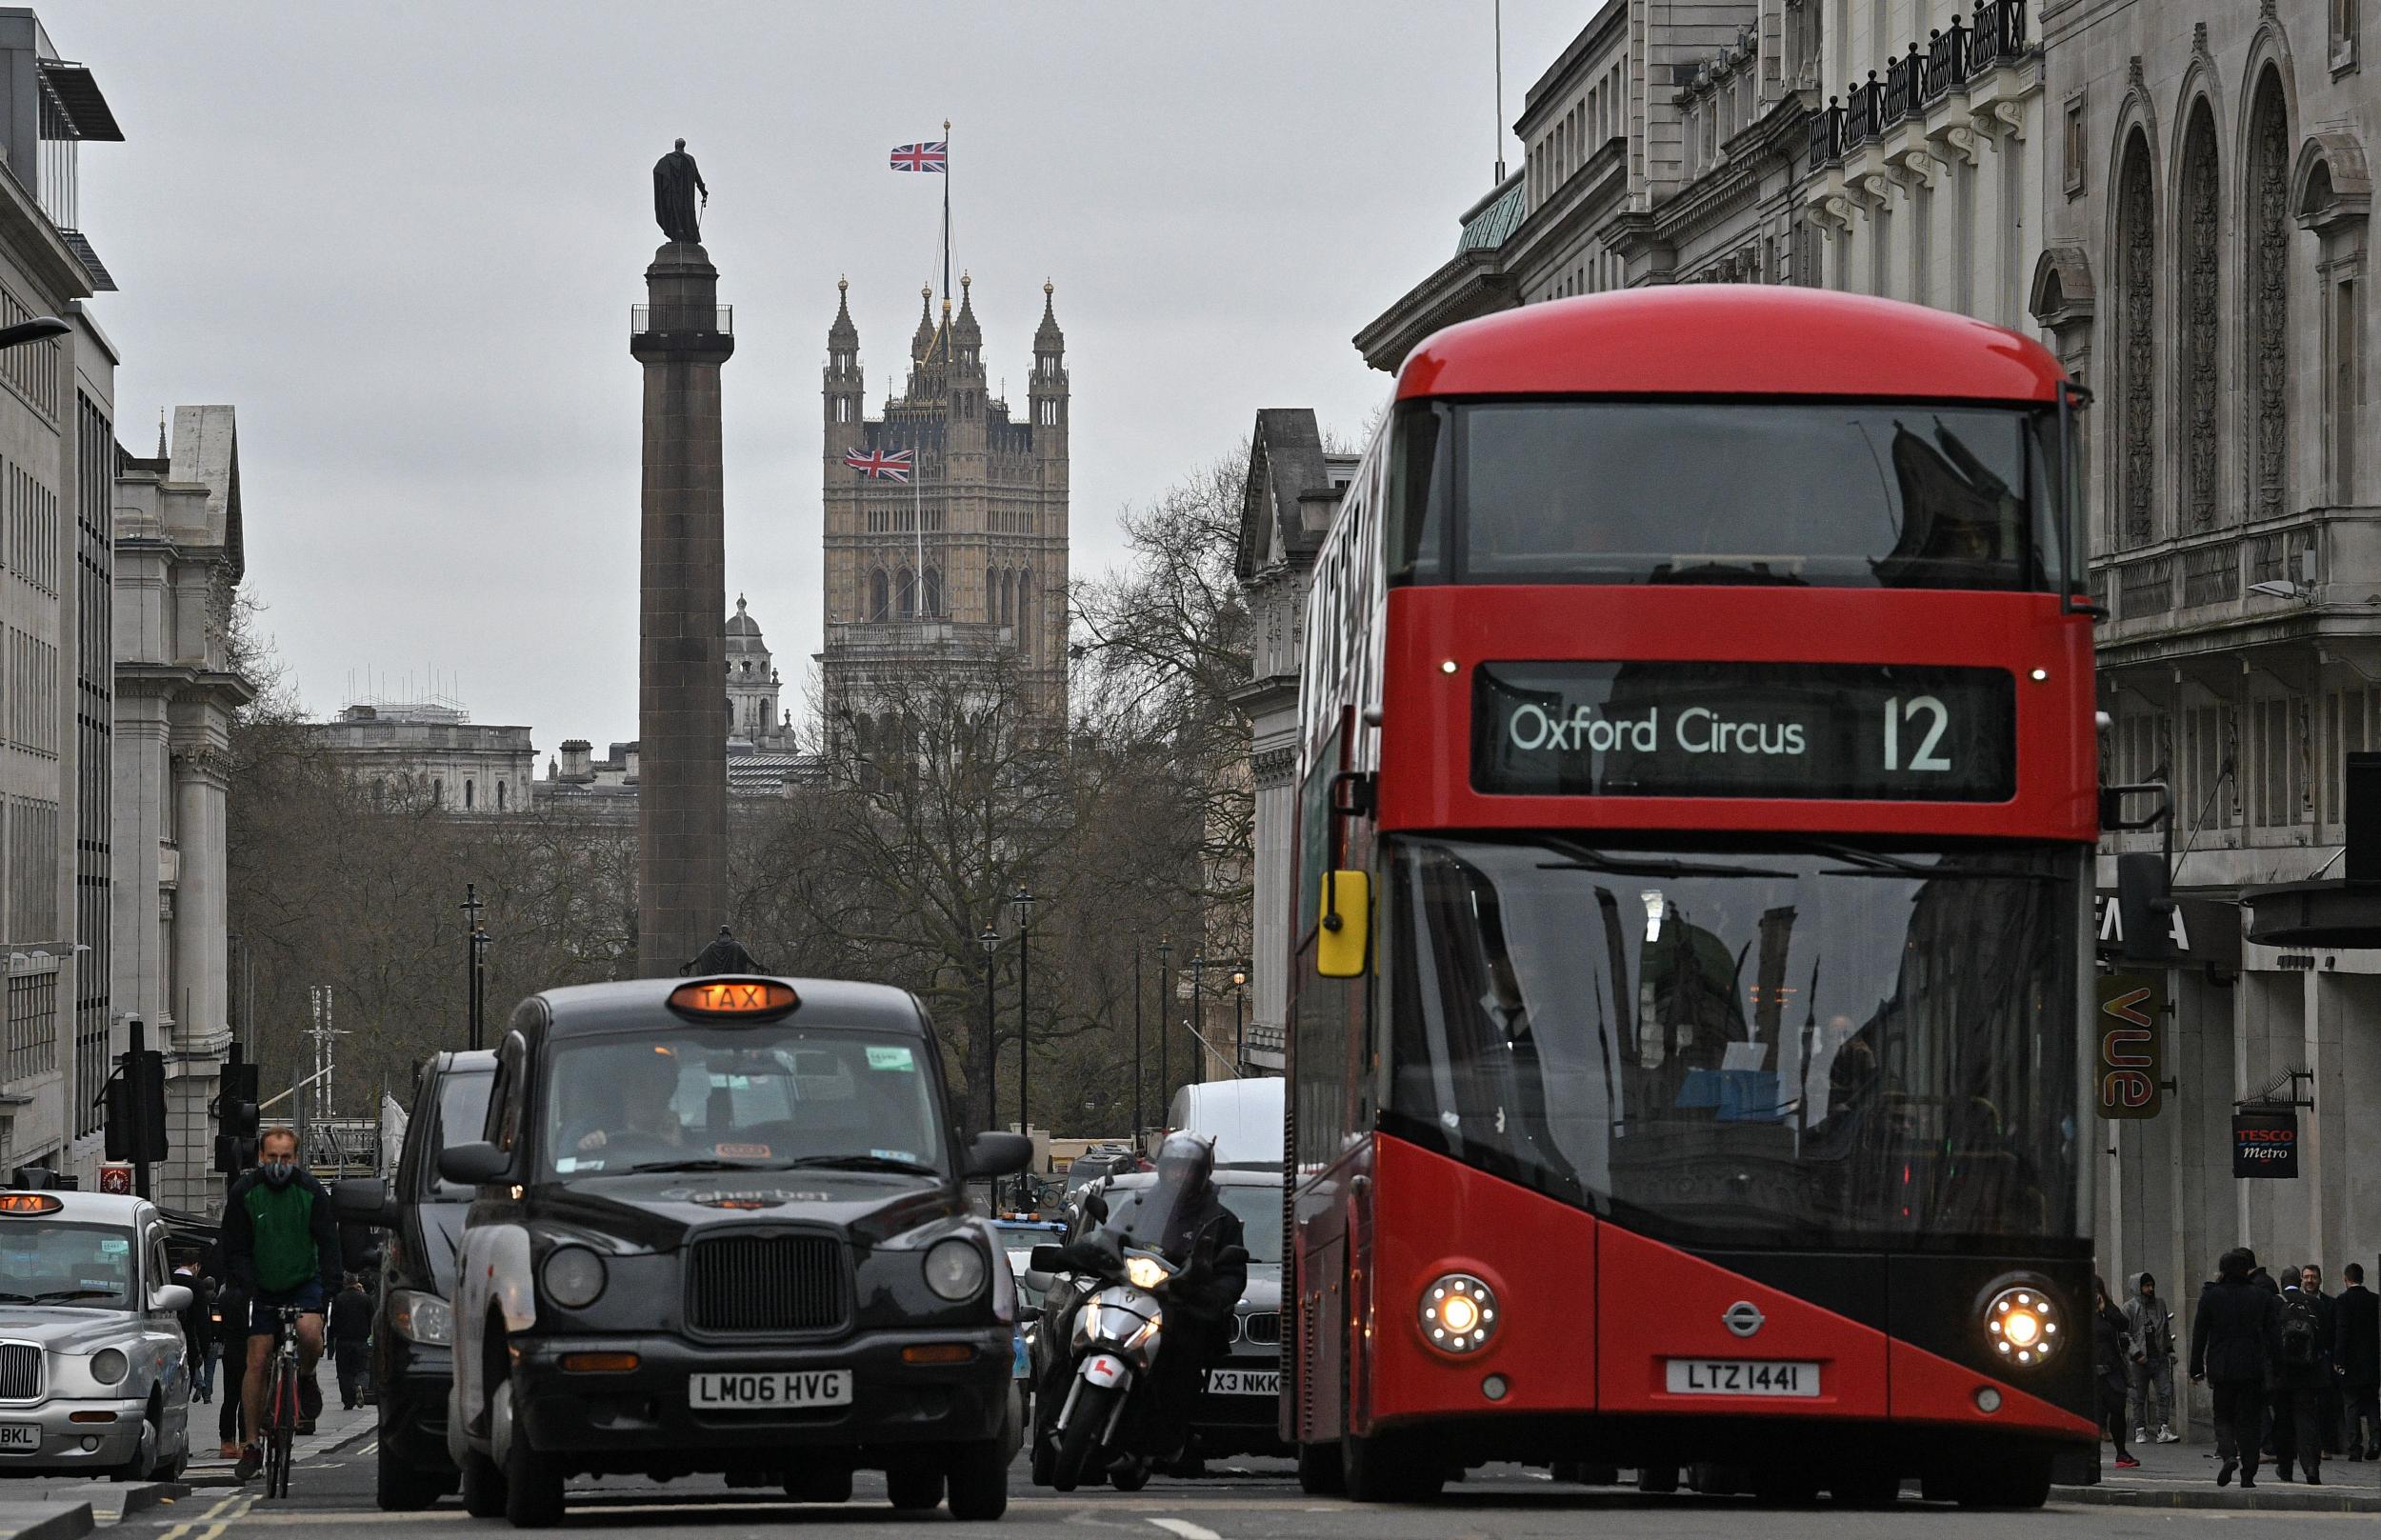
xmin=314 ymin=700 xmax=538 ymax=816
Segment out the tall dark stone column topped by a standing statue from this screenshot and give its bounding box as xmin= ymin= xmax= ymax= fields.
xmin=629 ymin=140 xmax=736 ymax=978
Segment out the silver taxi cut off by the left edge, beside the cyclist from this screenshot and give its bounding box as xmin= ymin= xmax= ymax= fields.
xmin=0 ymin=1192 xmax=190 ymax=1481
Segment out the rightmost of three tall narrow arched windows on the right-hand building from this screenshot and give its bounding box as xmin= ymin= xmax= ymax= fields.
xmin=2241 ymin=67 xmax=2291 ymax=519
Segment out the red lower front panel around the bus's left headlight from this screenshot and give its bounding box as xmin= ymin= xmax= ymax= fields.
xmin=1355 ymin=1135 xmax=1605 ymax=1433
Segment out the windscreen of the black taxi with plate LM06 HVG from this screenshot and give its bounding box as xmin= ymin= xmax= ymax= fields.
xmin=546 ymin=1024 xmax=948 ymax=1181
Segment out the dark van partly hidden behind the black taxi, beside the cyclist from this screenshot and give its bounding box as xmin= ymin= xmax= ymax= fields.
xmin=331 ymin=1054 xmax=495 ymax=1511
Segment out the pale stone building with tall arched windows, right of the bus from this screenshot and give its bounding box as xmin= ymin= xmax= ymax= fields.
xmin=2031 ymin=0 xmax=2381 ymax=1351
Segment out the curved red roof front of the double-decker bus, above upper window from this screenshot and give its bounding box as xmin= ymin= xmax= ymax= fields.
xmin=1398 ymin=283 xmax=2065 ymax=402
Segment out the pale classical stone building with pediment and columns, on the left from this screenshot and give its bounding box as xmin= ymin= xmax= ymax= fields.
xmin=112 ymin=407 xmax=255 ymax=1211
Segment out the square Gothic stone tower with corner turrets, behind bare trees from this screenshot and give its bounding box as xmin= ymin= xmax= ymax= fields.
xmin=819 ymin=276 xmax=1071 ymax=730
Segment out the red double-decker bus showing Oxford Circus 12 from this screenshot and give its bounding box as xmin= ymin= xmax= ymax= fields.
xmin=1284 ymin=286 xmax=2098 ymax=1505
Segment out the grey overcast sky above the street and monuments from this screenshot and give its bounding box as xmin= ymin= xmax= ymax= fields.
xmin=79 ymin=0 xmax=1595 ymax=757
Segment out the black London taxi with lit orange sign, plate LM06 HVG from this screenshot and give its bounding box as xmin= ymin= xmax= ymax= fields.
xmin=438 ymin=976 xmax=1031 ymax=1529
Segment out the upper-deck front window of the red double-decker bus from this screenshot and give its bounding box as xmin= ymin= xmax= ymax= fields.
xmin=1389 ymin=400 xmax=2062 ymax=590
